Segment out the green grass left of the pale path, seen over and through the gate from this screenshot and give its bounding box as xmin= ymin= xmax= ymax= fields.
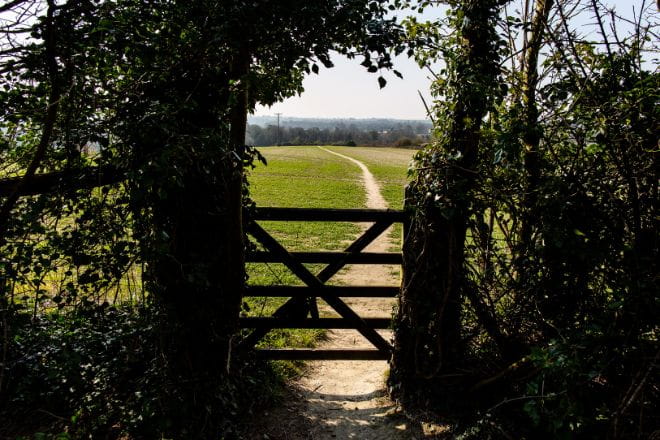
xmin=246 ymin=147 xmax=366 ymax=362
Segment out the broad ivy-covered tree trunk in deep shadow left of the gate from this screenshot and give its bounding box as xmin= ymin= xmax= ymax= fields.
xmin=118 ymin=42 xmax=249 ymax=438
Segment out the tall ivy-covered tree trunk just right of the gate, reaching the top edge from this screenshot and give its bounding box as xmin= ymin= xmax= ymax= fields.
xmin=390 ymin=0 xmax=501 ymax=403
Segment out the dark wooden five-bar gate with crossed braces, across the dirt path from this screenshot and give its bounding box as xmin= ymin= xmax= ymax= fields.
xmin=240 ymin=208 xmax=406 ymax=360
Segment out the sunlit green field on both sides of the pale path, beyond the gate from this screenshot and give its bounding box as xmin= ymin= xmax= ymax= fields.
xmin=247 ymin=147 xmax=413 ymax=362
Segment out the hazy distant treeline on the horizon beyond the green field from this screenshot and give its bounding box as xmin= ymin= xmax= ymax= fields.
xmin=247 ymin=123 xmax=429 ymax=147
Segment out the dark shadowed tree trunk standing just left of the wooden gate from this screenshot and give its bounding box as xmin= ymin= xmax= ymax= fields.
xmin=138 ymin=49 xmax=249 ymax=438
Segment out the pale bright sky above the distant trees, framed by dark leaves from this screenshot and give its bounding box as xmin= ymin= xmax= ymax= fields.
xmin=255 ymin=0 xmax=641 ymax=119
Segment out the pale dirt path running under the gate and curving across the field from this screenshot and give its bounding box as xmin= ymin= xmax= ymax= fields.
xmin=251 ymin=147 xmax=414 ymax=440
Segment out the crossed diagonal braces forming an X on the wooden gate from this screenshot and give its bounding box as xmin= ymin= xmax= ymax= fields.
xmin=241 ymin=220 xmax=392 ymax=352
